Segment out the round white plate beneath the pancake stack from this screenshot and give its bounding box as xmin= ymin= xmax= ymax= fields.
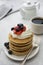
xmin=4 ymin=42 xmax=39 ymax=61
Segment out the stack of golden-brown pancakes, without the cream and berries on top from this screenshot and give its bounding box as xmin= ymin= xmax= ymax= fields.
xmin=9 ymin=34 xmax=33 ymax=56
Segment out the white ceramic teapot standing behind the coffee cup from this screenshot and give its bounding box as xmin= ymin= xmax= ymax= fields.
xmin=20 ymin=1 xmax=40 ymax=20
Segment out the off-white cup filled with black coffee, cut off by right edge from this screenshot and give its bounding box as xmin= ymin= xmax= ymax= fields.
xmin=30 ymin=17 xmax=43 ymax=34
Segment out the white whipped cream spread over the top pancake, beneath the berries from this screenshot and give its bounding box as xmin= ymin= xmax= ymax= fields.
xmin=10 ymin=28 xmax=32 ymax=39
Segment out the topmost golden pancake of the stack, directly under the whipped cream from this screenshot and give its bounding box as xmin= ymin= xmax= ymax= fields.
xmin=9 ymin=34 xmax=33 ymax=44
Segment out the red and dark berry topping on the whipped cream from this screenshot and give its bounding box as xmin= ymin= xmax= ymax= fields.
xmin=12 ymin=24 xmax=26 ymax=35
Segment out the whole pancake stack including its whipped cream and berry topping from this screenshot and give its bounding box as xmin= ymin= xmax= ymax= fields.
xmin=8 ymin=24 xmax=33 ymax=56
